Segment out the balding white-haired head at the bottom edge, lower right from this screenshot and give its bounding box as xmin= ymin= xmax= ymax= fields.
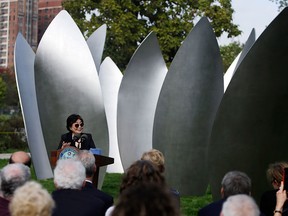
xmin=220 ymin=194 xmax=260 ymax=216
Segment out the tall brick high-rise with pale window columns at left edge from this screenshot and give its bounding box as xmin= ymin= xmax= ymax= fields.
xmin=0 ymin=0 xmax=38 ymax=68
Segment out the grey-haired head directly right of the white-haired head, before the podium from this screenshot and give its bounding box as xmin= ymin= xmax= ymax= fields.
xmin=77 ymin=150 xmax=96 ymax=178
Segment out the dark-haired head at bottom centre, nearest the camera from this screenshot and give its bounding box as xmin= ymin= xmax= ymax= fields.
xmin=112 ymin=182 xmax=180 ymax=216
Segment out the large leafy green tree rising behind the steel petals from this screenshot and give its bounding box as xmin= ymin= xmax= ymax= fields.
xmin=63 ymin=0 xmax=241 ymax=70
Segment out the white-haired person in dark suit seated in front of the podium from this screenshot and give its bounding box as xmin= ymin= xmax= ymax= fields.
xmin=52 ymin=159 xmax=105 ymax=216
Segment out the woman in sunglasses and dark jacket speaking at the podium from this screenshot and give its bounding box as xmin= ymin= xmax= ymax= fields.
xmin=57 ymin=114 xmax=95 ymax=150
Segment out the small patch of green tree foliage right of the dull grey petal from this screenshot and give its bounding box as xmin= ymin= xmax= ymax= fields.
xmin=220 ymin=42 xmax=243 ymax=72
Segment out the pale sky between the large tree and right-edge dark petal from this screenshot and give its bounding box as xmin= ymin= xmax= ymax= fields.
xmin=218 ymin=0 xmax=279 ymax=45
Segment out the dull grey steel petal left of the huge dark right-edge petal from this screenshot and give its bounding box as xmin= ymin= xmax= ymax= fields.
xmin=153 ymin=18 xmax=223 ymax=195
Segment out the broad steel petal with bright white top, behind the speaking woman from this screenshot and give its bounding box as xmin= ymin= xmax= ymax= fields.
xmin=35 ymin=11 xmax=109 ymax=185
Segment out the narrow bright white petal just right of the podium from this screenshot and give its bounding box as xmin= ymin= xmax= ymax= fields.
xmin=99 ymin=57 xmax=124 ymax=173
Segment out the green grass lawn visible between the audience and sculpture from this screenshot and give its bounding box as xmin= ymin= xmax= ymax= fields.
xmin=0 ymin=159 xmax=212 ymax=216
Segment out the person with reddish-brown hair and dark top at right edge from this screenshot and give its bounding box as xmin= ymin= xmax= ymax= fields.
xmin=260 ymin=161 xmax=288 ymax=216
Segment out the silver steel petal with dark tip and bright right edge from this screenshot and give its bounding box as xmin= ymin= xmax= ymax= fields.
xmin=117 ymin=32 xmax=167 ymax=170
